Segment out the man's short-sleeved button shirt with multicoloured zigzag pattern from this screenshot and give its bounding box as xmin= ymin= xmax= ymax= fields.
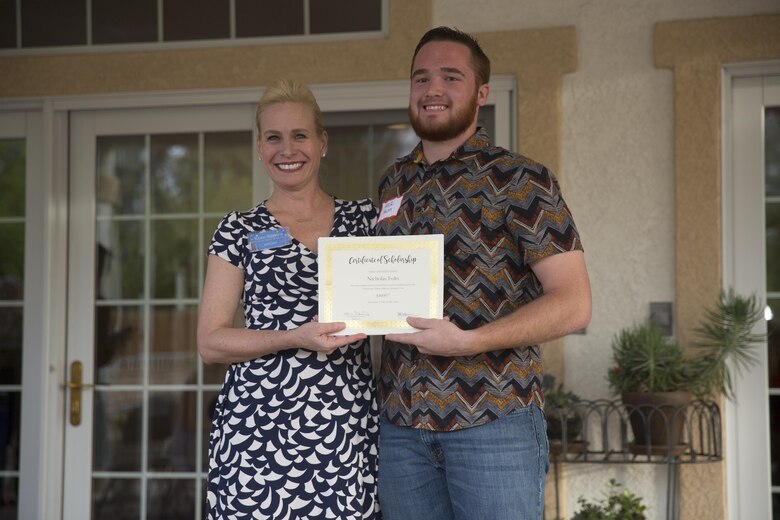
xmin=377 ymin=130 xmax=582 ymax=431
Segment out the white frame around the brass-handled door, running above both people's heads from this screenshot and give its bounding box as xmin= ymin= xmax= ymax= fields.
xmin=0 ymin=76 xmax=517 ymax=520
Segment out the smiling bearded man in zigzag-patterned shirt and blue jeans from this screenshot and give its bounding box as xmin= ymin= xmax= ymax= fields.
xmin=377 ymin=27 xmax=591 ymax=520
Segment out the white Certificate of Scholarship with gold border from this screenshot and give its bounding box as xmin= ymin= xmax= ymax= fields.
xmin=317 ymin=235 xmax=444 ymax=335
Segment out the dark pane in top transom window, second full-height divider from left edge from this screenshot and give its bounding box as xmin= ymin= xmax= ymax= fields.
xmin=22 ymin=0 xmax=87 ymax=47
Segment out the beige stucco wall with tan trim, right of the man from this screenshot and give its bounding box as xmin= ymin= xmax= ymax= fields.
xmin=433 ymin=0 xmax=780 ymax=519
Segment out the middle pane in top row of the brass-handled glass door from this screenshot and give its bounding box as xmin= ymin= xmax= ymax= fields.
xmin=151 ymin=134 xmax=198 ymax=213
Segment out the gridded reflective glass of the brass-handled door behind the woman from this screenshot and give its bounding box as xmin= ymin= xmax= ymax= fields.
xmin=92 ymin=130 xmax=253 ymax=520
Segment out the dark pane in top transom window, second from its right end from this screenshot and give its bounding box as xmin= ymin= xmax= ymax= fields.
xmin=236 ymin=0 xmax=304 ymax=38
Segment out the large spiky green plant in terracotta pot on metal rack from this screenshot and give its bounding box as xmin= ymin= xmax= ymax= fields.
xmin=607 ymin=290 xmax=765 ymax=448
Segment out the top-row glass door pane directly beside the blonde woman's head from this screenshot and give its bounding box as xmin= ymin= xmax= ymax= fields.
xmin=203 ymin=131 xmax=254 ymax=213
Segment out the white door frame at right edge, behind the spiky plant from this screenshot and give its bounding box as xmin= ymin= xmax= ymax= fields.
xmin=721 ymin=62 xmax=780 ymax=519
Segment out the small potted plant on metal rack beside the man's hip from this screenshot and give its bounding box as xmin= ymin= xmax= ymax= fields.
xmin=542 ymin=374 xmax=582 ymax=451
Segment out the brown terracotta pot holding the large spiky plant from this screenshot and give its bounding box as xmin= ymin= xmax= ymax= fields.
xmin=622 ymin=392 xmax=693 ymax=451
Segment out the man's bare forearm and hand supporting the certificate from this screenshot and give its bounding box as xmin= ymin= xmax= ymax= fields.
xmin=387 ymin=251 xmax=591 ymax=356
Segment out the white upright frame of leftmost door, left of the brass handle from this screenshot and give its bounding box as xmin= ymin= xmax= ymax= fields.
xmin=0 ymin=101 xmax=66 ymax=519
